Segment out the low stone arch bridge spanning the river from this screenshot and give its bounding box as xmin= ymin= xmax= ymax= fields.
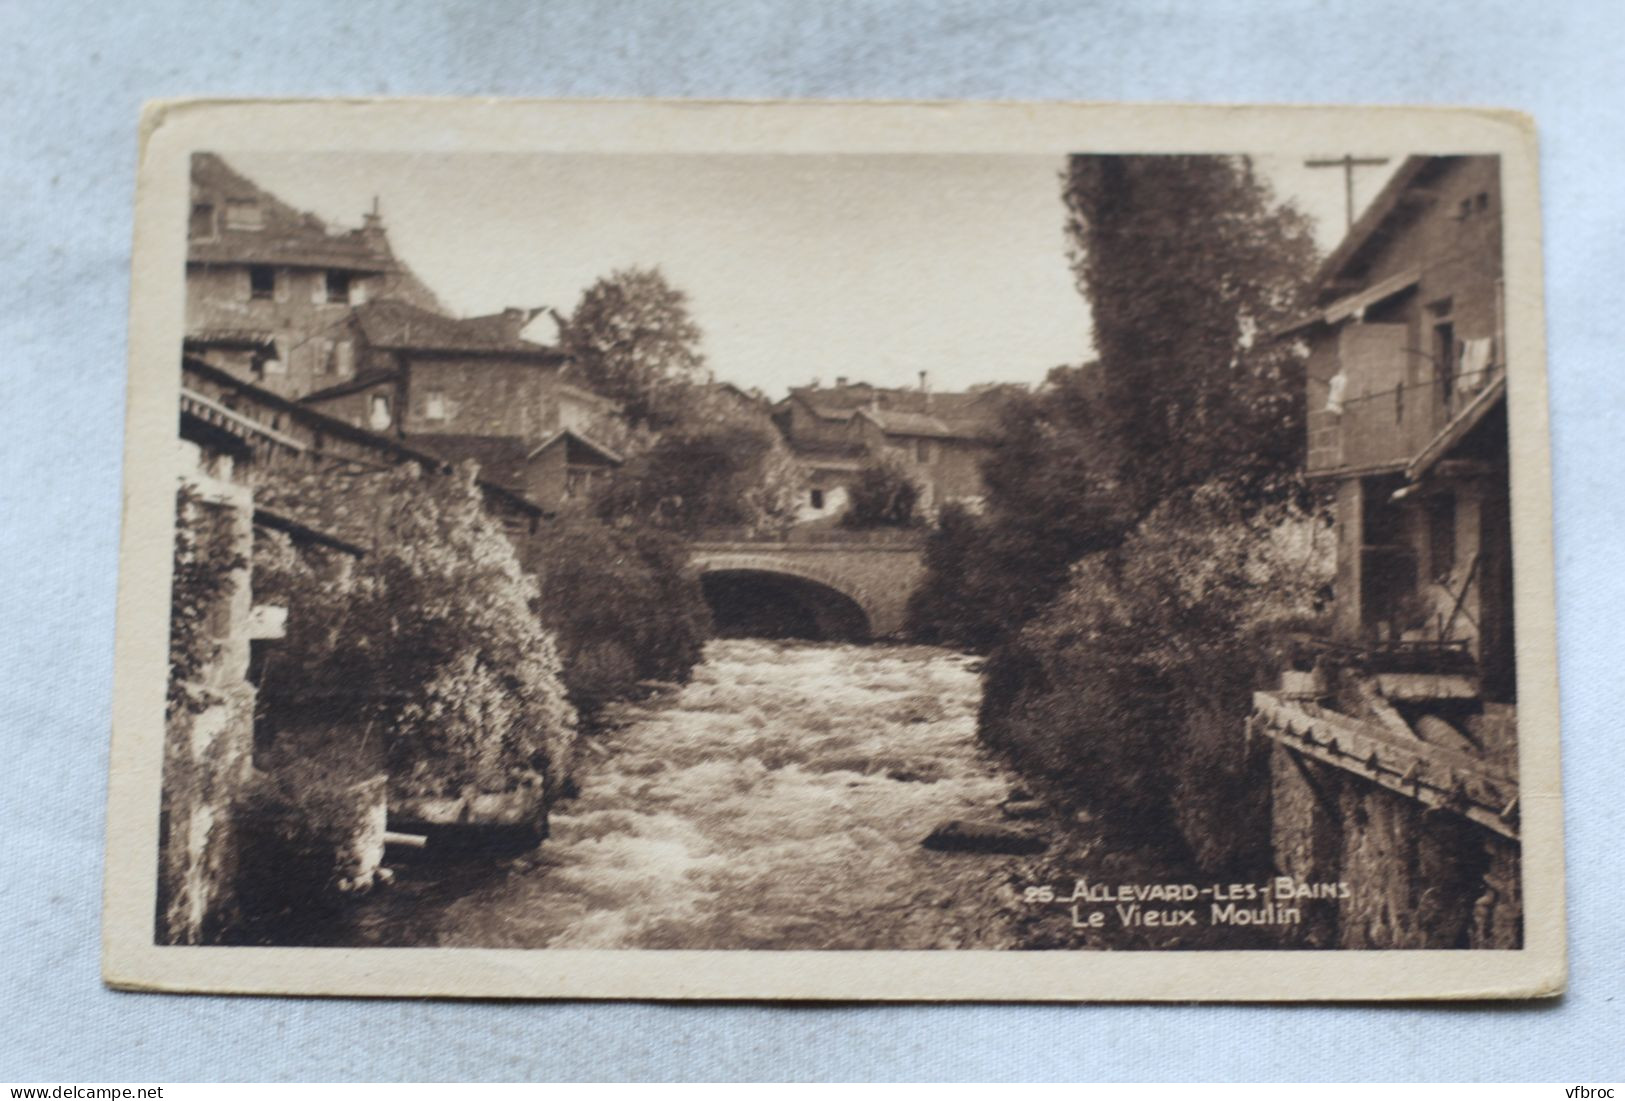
xmin=691 ymin=531 xmax=925 ymax=640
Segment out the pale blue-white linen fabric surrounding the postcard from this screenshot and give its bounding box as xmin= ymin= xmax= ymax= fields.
xmin=0 ymin=0 xmax=1625 ymax=1083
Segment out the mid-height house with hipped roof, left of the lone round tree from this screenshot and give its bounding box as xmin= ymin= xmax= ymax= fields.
xmin=302 ymin=300 xmax=621 ymax=512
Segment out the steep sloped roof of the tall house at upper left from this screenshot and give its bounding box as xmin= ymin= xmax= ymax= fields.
xmin=187 ymin=153 xmax=397 ymax=271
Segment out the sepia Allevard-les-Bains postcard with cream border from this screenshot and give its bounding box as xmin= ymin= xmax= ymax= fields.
xmin=104 ymin=101 xmax=1567 ymax=1000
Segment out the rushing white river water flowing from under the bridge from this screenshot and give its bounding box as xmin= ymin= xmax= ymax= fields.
xmin=362 ymin=640 xmax=1040 ymax=948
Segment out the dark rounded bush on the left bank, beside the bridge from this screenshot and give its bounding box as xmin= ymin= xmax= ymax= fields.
xmin=525 ymin=516 xmax=710 ymax=716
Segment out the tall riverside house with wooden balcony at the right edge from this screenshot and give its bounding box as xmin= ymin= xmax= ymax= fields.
xmin=1248 ymin=156 xmax=1523 ymax=948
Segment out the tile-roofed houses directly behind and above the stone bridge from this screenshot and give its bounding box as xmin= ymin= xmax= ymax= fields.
xmin=774 ymin=372 xmax=999 ymax=521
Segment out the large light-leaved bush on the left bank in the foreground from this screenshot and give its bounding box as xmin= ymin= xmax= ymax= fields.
xmin=255 ymin=466 xmax=575 ymax=794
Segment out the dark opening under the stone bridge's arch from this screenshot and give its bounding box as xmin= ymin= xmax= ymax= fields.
xmin=700 ymin=568 xmax=871 ymax=641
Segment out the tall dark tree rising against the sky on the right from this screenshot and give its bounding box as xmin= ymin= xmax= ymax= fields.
xmin=1063 ymin=156 xmax=1316 ymax=513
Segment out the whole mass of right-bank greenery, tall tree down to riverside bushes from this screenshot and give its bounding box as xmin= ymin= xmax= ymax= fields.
xmin=910 ymin=156 xmax=1331 ymax=870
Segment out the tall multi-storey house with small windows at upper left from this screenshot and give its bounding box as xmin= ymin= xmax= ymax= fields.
xmin=185 ymin=153 xmax=439 ymax=398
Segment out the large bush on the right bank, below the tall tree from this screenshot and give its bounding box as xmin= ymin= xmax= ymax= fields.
xmin=982 ymin=486 xmax=1333 ymax=870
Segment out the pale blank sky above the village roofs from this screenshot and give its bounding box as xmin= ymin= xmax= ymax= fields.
xmin=221 ymin=149 xmax=1399 ymax=398
